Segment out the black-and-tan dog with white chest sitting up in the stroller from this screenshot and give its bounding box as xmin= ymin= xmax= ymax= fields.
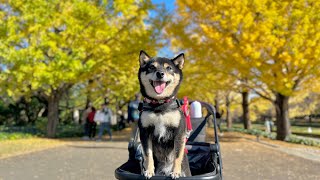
xmin=138 ymin=51 xmax=191 ymax=179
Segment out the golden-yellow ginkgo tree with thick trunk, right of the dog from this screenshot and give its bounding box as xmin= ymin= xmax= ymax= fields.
xmin=168 ymin=0 xmax=320 ymax=140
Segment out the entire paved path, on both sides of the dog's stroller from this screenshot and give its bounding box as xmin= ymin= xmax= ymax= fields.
xmin=0 ymin=133 xmax=320 ymax=180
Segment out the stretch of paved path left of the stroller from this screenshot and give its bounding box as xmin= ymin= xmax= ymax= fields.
xmin=0 ymin=142 xmax=128 ymax=180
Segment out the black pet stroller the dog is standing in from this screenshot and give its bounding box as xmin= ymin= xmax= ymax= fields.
xmin=115 ymin=102 xmax=222 ymax=180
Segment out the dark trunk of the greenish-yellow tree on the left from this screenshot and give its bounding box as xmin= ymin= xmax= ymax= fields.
xmin=47 ymin=94 xmax=60 ymax=138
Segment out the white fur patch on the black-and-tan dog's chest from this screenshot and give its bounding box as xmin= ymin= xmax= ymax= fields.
xmin=141 ymin=110 xmax=181 ymax=138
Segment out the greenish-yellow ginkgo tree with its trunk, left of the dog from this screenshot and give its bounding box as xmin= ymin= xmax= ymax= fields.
xmin=0 ymin=0 xmax=162 ymax=137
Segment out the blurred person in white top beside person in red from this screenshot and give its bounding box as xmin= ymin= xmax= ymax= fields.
xmin=95 ymin=102 xmax=112 ymax=141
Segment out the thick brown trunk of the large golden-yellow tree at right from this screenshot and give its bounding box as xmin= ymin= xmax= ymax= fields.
xmin=275 ymin=93 xmax=291 ymax=141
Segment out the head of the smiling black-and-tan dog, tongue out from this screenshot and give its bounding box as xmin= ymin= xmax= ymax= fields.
xmin=138 ymin=51 xmax=184 ymax=100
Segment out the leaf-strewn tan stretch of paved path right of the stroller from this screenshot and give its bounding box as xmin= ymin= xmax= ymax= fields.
xmin=221 ymin=134 xmax=320 ymax=180
